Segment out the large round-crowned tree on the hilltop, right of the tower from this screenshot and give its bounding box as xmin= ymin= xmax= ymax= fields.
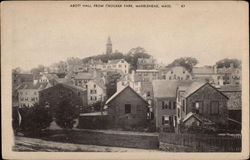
xmin=125 ymin=47 xmax=150 ymax=69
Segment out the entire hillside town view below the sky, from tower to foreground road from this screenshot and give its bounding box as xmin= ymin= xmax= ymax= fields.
xmin=12 ymin=37 xmax=242 ymax=152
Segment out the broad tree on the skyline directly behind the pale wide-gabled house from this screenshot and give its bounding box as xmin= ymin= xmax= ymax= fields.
xmin=167 ymin=57 xmax=198 ymax=72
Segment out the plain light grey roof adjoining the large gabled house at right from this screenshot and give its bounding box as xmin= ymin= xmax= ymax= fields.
xmin=152 ymin=80 xmax=193 ymax=98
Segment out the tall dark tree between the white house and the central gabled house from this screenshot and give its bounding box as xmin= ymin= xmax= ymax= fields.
xmin=106 ymin=71 xmax=121 ymax=98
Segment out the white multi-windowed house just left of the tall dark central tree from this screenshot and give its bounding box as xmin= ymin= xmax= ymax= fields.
xmin=86 ymin=79 xmax=106 ymax=105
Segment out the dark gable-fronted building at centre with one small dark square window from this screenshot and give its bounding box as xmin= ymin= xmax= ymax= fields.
xmin=105 ymin=86 xmax=148 ymax=127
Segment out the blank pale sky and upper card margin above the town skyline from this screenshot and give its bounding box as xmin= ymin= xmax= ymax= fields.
xmin=2 ymin=2 xmax=248 ymax=70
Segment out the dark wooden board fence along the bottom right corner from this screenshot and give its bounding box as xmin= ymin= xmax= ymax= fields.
xmin=159 ymin=133 xmax=241 ymax=152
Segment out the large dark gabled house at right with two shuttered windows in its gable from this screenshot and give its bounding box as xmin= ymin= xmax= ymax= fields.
xmin=176 ymin=81 xmax=228 ymax=128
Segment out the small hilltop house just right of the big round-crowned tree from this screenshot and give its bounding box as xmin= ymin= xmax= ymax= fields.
xmin=137 ymin=57 xmax=156 ymax=70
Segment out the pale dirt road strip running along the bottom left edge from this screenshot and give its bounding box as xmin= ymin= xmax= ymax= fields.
xmin=13 ymin=136 xmax=160 ymax=152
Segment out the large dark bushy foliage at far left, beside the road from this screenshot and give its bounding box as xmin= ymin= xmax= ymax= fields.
xmin=16 ymin=104 xmax=52 ymax=135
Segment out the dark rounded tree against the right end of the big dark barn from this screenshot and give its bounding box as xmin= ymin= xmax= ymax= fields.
xmin=55 ymin=99 xmax=80 ymax=129
